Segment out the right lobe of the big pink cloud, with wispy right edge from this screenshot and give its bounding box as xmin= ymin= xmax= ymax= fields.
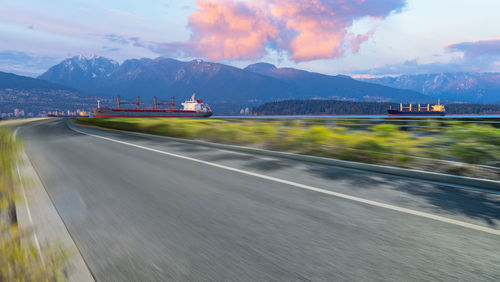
xmin=272 ymin=0 xmax=405 ymax=61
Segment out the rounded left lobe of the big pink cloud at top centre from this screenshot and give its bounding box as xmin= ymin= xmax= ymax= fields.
xmin=188 ymin=0 xmax=279 ymax=60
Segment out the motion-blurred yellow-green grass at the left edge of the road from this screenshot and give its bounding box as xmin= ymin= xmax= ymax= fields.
xmin=0 ymin=127 xmax=66 ymax=281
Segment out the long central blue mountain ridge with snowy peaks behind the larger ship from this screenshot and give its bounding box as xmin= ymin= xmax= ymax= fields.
xmin=39 ymin=56 xmax=432 ymax=108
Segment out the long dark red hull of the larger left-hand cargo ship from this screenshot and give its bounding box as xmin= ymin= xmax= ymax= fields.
xmin=93 ymin=108 xmax=213 ymax=118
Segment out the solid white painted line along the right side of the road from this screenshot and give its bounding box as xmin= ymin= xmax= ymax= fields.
xmin=70 ymin=126 xmax=500 ymax=235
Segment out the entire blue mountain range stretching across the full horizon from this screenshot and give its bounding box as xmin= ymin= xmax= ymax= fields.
xmin=0 ymin=56 xmax=500 ymax=115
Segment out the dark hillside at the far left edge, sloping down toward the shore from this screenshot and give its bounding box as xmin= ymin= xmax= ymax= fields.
xmin=0 ymin=72 xmax=106 ymax=116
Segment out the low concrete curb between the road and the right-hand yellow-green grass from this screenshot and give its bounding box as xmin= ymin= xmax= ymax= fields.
xmin=67 ymin=120 xmax=500 ymax=191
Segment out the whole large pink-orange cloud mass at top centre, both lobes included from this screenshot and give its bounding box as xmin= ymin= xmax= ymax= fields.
xmin=156 ymin=0 xmax=406 ymax=62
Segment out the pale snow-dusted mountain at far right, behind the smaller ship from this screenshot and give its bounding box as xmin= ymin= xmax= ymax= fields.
xmin=360 ymin=73 xmax=500 ymax=104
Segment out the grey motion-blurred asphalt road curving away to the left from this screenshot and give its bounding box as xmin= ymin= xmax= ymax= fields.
xmin=19 ymin=120 xmax=500 ymax=281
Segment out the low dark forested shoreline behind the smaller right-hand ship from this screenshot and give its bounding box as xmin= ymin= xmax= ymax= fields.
xmin=252 ymin=100 xmax=500 ymax=115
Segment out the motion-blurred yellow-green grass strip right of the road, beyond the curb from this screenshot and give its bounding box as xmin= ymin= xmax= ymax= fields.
xmin=77 ymin=118 xmax=500 ymax=170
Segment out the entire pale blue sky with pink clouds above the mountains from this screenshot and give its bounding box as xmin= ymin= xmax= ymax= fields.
xmin=0 ymin=0 xmax=500 ymax=77
